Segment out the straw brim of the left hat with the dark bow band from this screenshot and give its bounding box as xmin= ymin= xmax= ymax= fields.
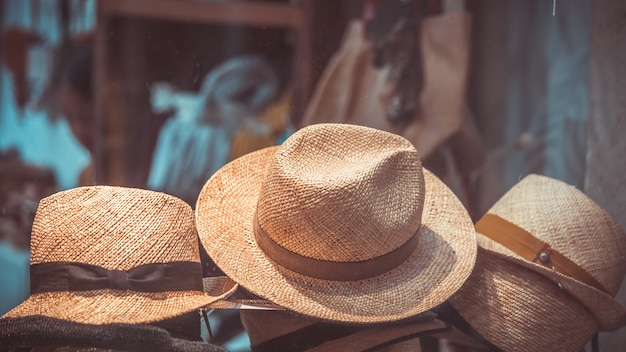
xmin=2 ymin=280 xmax=237 ymax=325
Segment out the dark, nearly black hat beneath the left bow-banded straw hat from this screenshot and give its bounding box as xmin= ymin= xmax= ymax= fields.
xmin=0 ymin=315 xmax=226 ymax=352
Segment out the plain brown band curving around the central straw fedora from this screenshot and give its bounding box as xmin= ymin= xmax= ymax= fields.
xmin=254 ymin=214 xmax=419 ymax=281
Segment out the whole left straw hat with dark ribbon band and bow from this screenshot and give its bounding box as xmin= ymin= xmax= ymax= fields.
xmin=3 ymin=186 xmax=236 ymax=324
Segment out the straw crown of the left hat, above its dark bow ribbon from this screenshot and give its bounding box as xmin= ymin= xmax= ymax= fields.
xmin=31 ymin=186 xmax=200 ymax=270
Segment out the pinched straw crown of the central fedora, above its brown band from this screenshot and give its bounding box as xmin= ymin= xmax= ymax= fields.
xmin=257 ymin=124 xmax=424 ymax=262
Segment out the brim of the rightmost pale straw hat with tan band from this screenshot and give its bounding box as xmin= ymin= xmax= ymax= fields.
xmin=478 ymin=233 xmax=626 ymax=331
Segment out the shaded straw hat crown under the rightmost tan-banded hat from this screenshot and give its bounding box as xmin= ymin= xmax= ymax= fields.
xmin=450 ymin=248 xmax=598 ymax=352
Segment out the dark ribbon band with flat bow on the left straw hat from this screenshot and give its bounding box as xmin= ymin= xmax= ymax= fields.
xmin=30 ymin=262 xmax=202 ymax=294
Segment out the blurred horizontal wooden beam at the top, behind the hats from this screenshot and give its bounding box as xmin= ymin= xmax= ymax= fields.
xmin=100 ymin=0 xmax=302 ymax=28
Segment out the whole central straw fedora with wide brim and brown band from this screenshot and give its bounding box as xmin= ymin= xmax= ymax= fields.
xmin=196 ymin=124 xmax=476 ymax=323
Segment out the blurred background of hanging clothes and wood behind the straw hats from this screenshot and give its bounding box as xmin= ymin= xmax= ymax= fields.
xmin=0 ymin=0 xmax=626 ymax=351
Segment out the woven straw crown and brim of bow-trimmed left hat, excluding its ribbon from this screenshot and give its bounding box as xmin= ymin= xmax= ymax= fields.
xmin=5 ymin=186 xmax=235 ymax=324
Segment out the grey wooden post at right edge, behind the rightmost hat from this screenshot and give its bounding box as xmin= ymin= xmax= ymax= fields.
xmin=585 ymin=0 xmax=626 ymax=351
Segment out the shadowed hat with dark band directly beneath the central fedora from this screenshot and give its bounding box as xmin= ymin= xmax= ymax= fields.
xmin=241 ymin=310 xmax=448 ymax=352
